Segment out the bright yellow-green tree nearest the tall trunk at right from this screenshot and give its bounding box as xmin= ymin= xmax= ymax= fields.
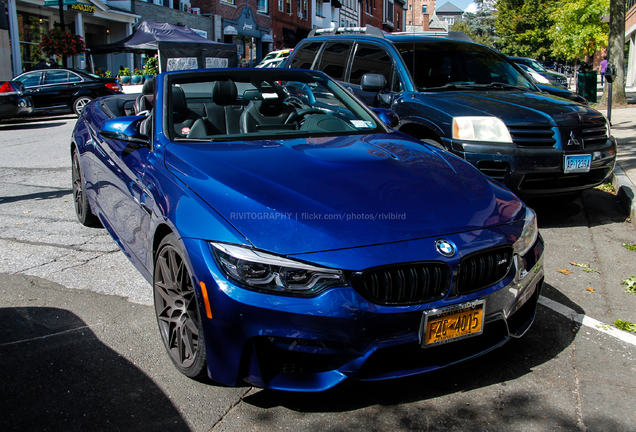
xmin=548 ymin=0 xmax=610 ymax=60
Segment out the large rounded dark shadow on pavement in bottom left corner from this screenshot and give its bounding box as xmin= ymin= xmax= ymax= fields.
xmin=0 ymin=307 xmax=189 ymax=431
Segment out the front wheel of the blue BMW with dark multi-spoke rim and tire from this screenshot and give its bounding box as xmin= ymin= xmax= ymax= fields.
xmin=153 ymin=234 xmax=206 ymax=378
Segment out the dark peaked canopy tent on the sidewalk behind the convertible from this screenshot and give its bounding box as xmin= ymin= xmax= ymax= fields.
xmin=89 ymin=21 xmax=238 ymax=72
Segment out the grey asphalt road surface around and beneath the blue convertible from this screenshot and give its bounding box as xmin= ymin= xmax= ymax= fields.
xmin=0 ymin=116 xmax=636 ymax=432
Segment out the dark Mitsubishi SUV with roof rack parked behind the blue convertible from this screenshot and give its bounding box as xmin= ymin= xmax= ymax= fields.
xmin=287 ymin=26 xmax=616 ymax=199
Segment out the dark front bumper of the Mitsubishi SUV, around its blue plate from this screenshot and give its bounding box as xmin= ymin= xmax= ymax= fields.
xmin=448 ymin=137 xmax=616 ymax=198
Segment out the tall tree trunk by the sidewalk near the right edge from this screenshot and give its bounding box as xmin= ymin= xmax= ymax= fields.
xmin=600 ymin=0 xmax=627 ymax=105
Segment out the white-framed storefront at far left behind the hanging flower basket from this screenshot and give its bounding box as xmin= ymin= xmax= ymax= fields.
xmin=2 ymin=0 xmax=139 ymax=76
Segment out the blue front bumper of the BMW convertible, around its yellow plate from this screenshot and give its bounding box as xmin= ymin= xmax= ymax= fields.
xmin=184 ymin=237 xmax=544 ymax=392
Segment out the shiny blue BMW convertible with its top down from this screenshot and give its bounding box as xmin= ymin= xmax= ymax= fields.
xmin=71 ymin=69 xmax=544 ymax=391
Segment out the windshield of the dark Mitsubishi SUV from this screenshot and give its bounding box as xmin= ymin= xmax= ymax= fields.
xmin=396 ymin=40 xmax=535 ymax=91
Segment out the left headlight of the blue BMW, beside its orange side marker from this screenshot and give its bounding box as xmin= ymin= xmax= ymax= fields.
xmin=212 ymin=243 xmax=347 ymax=295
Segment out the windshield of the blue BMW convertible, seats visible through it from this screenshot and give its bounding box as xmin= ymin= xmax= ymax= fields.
xmin=166 ymin=69 xmax=387 ymax=142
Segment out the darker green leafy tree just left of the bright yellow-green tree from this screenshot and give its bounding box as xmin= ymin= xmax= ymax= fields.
xmin=495 ymin=0 xmax=559 ymax=58
